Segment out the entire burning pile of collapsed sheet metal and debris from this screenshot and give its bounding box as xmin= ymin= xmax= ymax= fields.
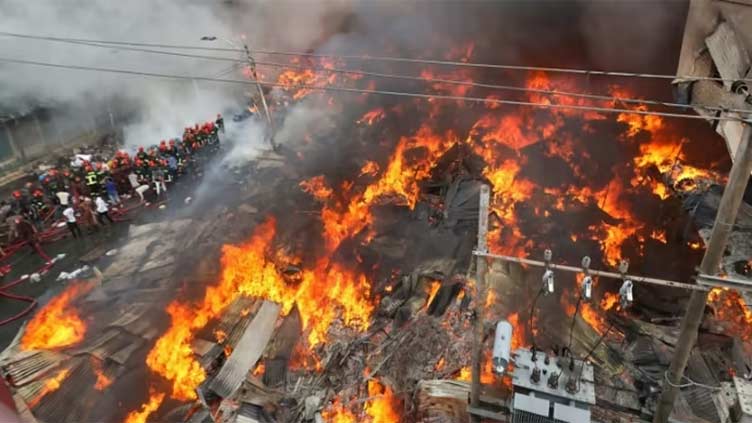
xmin=4 ymin=48 xmax=752 ymax=423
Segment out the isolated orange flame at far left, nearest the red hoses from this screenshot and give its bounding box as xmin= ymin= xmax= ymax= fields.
xmin=21 ymin=282 xmax=94 ymax=350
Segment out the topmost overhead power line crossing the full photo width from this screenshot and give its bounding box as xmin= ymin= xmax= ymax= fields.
xmin=0 ymin=31 xmax=752 ymax=82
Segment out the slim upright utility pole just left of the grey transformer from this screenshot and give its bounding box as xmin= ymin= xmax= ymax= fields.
xmin=470 ymin=185 xmax=491 ymax=423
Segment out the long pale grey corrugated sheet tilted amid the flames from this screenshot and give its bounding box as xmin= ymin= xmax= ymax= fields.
xmin=209 ymin=301 xmax=280 ymax=398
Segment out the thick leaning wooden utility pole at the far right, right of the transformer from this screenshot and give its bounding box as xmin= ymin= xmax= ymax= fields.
xmin=653 ymin=122 xmax=752 ymax=423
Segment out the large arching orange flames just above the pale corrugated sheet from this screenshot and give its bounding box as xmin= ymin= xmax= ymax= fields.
xmin=146 ymin=219 xmax=373 ymax=406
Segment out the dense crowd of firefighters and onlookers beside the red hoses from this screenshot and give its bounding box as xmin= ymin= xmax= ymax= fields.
xmin=0 ymin=115 xmax=224 ymax=250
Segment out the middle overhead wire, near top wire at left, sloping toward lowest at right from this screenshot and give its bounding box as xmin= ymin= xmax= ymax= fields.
xmin=0 ymin=32 xmax=752 ymax=117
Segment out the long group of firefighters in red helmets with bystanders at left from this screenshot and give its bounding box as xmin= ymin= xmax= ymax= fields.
xmin=0 ymin=115 xmax=224 ymax=242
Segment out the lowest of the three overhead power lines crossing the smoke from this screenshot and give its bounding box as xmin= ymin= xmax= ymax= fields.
xmin=0 ymin=57 xmax=752 ymax=123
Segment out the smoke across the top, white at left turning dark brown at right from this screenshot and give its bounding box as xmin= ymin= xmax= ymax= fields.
xmin=0 ymin=0 xmax=685 ymax=152
